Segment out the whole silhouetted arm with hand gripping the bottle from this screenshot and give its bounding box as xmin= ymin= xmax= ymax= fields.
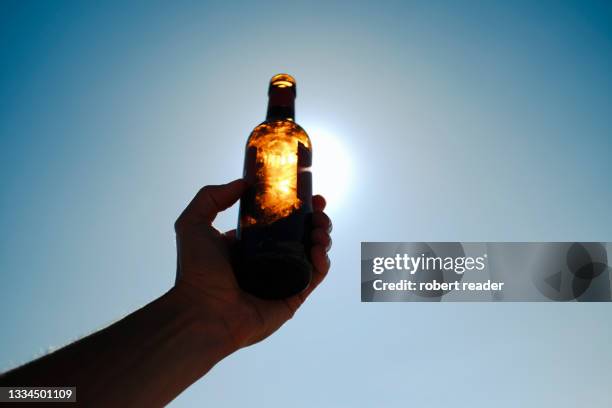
xmin=0 ymin=180 xmax=331 ymax=407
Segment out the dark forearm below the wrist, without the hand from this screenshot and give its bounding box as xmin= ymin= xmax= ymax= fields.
xmin=0 ymin=291 xmax=234 ymax=406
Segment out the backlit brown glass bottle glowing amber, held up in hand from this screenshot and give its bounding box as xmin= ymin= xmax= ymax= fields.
xmin=235 ymin=74 xmax=312 ymax=299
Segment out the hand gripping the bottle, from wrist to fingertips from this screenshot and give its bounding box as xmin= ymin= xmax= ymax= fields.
xmin=173 ymin=179 xmax=331 ymax=349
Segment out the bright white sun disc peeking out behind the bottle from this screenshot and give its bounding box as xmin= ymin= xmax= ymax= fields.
xmin=308 ymin=127 xmax=351 ymax=212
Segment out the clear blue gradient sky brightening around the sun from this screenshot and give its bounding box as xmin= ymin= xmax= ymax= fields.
xmin=0 ymin=0 xmax=612 ymax=408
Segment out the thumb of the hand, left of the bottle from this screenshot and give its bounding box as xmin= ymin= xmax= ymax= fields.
xmin=176 ymin=179 xmax=246 ymax=228
